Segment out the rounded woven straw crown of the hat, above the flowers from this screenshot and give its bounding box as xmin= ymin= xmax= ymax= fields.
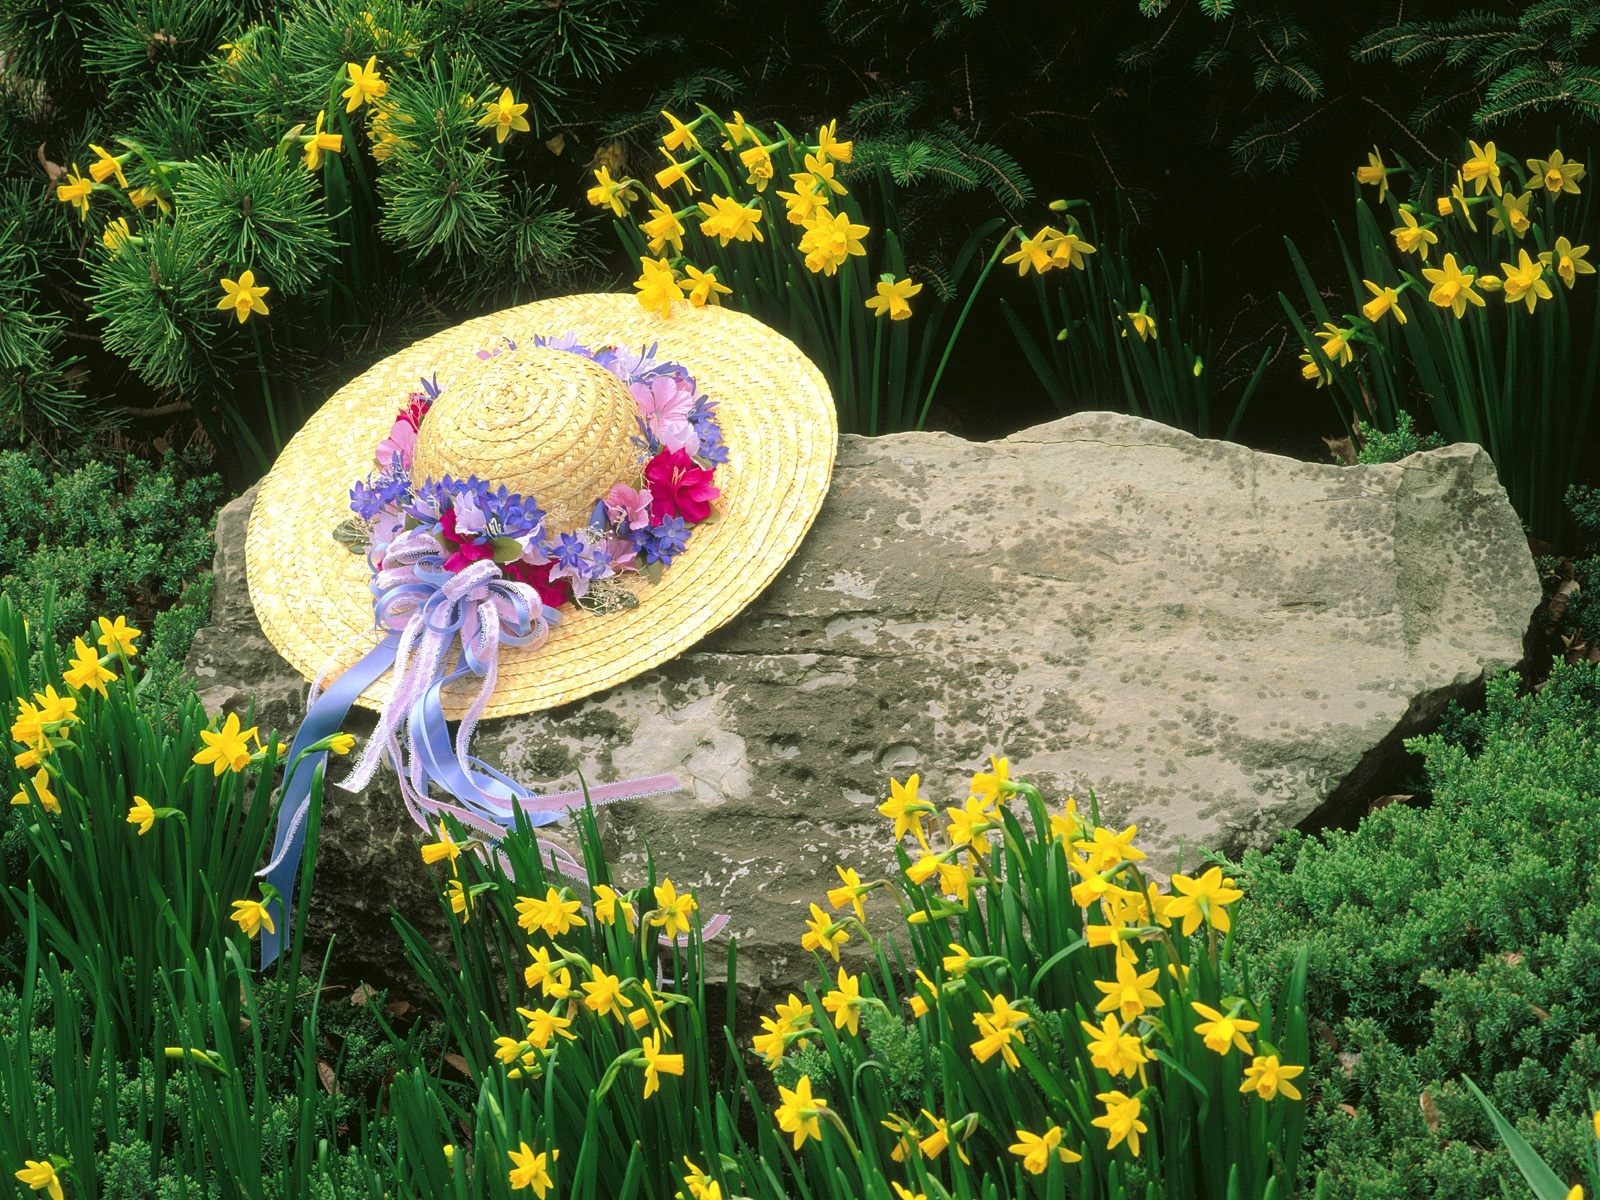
xmin=411 ymin=347 xmax=638 ymax=533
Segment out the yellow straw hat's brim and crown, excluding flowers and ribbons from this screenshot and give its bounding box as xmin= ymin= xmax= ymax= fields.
xmin=245 ymin=294 xmax=838 ymax=717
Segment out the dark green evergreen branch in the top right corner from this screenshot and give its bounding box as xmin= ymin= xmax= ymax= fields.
xmin=1352 ymin=0 xmax=1600 ymax=130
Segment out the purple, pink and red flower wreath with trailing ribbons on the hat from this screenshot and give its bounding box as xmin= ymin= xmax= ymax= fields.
xmin=259 ymin=334 xmax=728 ymax=966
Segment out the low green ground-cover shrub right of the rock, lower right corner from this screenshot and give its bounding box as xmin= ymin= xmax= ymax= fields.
xmin=1240 ymin=664 xmax=1600 ymax=1200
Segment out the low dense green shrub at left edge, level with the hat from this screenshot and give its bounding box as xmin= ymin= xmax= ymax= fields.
xmin=0 ymin=450 xmax=221 ymax=694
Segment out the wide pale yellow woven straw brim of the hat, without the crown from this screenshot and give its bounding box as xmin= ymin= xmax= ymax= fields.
xmin=245 ymin=294 xmax=838 ymax=717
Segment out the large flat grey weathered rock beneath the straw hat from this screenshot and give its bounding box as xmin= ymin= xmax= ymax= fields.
xmin=189 ymin=413 xmax=1539 ymax=984
